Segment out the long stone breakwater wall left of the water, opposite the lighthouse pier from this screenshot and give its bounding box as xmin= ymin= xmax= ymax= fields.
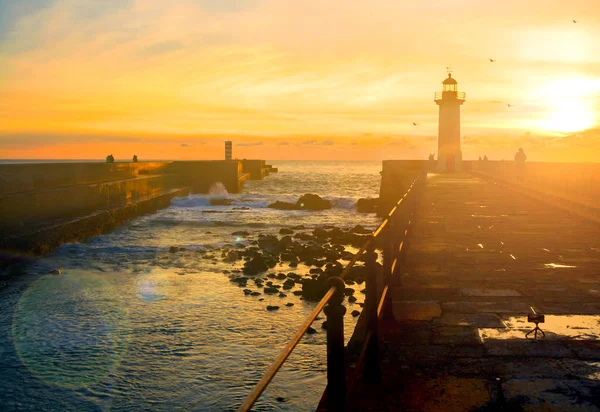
xmin=0 ymin=160 xmax=272 ymax=253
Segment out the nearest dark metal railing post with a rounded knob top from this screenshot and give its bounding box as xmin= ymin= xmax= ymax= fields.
xmin=325 ymin=277 xmax=346 ymax=411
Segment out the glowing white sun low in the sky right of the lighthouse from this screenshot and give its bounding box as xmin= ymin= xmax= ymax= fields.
xmin=540 ymin=101 xmax=595 ymax=133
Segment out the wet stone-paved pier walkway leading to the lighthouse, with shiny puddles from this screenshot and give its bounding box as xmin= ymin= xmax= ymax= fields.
xmin=349 ymin=174 xmax=600 ymax=411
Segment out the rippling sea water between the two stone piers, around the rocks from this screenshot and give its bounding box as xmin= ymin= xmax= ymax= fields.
xmin=0 ymin=162 xmax=381 ymax=411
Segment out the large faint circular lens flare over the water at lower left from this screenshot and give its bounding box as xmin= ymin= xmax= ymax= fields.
xmin=12 ymin=272 xmax=129 ymax=389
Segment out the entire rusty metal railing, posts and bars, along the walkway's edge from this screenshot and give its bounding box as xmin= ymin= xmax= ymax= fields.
xmin=238 ymin=175 xmax=422 ymax=412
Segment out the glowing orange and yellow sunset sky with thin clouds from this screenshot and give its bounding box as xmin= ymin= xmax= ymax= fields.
xmin=0 ymin=0 xmax=600 ymax=161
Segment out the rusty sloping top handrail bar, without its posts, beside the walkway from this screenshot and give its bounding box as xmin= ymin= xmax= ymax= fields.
xmin=238 ymin=177 xmax=419 ymax=412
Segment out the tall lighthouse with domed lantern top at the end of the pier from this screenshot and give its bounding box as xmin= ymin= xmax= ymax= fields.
xmin=435 ymin=72 xmax=465 ymax=173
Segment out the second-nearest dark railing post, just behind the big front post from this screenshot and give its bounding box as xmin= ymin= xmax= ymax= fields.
xmin=365 ymin=245 xmax=381 ymax=382
